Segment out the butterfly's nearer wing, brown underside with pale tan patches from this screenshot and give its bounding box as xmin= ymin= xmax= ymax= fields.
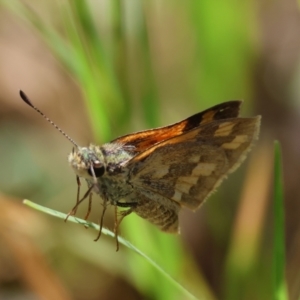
xmin=126 ymin=117 xmax=260 ymax=209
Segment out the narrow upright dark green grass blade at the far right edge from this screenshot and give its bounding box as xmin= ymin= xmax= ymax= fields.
xmin=273 ymin=141 xmax=288 ymax=300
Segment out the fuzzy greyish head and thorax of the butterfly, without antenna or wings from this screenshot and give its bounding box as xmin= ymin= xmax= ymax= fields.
xmin=68 ymin=143 xmax=132 ymax=205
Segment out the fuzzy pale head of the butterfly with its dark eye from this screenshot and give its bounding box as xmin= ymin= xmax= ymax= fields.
xmin=68 ymin=145 xmax=105 ymax=179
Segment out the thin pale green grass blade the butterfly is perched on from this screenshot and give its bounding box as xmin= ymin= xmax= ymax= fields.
xmin=23 ymin=200 xmax=197 ymax=299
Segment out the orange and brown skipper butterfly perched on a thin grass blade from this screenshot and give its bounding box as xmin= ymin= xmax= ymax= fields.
xmin=20 ymin=91 xmax=261 ymax=250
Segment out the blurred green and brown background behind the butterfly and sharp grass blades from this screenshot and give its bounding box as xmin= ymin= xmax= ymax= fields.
xmin=0 ymin=0 xmax=300 ymax=300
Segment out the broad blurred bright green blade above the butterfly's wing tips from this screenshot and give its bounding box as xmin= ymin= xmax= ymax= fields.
xmin=187 ymin=1 xmax=257 ymax=105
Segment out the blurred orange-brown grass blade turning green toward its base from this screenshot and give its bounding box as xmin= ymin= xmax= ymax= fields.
xmin=222 ymin=144 xmax=273 ymax=300
